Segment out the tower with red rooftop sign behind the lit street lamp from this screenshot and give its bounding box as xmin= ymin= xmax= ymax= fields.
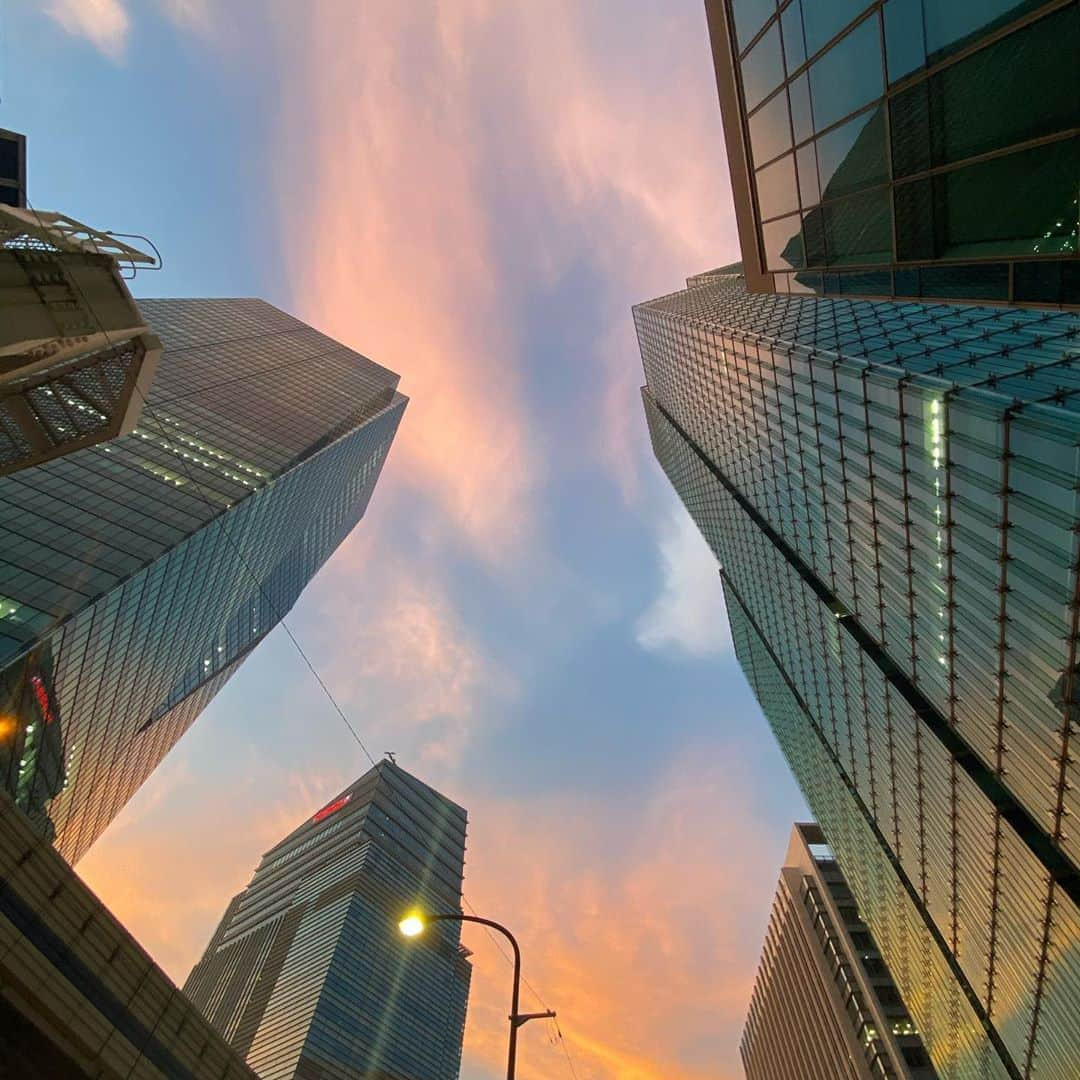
xmin=184 ymin=761 xmax=472 ymax=1080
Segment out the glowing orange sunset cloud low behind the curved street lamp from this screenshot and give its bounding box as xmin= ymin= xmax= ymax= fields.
xmin=465 ymin=744 xmax=783 ymax=1080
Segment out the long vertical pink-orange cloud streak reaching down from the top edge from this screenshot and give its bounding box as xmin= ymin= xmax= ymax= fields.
xmin=270 ymin=3 xmax=542 ymax=563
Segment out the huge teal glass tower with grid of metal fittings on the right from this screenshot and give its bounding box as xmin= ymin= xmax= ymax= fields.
xmin=635 ymin=278 xmax=1080 ymax=1080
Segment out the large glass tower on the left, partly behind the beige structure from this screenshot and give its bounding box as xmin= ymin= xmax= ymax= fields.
xmin=0 ymin=299 xmax=406 ymax=861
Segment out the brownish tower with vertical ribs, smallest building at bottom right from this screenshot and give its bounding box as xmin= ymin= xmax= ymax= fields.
xmin=740 ymin=824 xmax=934 ymax=1080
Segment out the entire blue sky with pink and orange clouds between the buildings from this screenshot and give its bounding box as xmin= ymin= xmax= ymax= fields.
xmin=0 ymin=0 xmax=807 ymax=1080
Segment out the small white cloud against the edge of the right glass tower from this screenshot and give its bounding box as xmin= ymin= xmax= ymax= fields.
xmin=635 ymin=504 xmax=731 ymax=657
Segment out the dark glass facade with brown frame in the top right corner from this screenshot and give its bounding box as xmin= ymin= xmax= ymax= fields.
xmin=713 ymin=0 xmax=1080 ymax=306
